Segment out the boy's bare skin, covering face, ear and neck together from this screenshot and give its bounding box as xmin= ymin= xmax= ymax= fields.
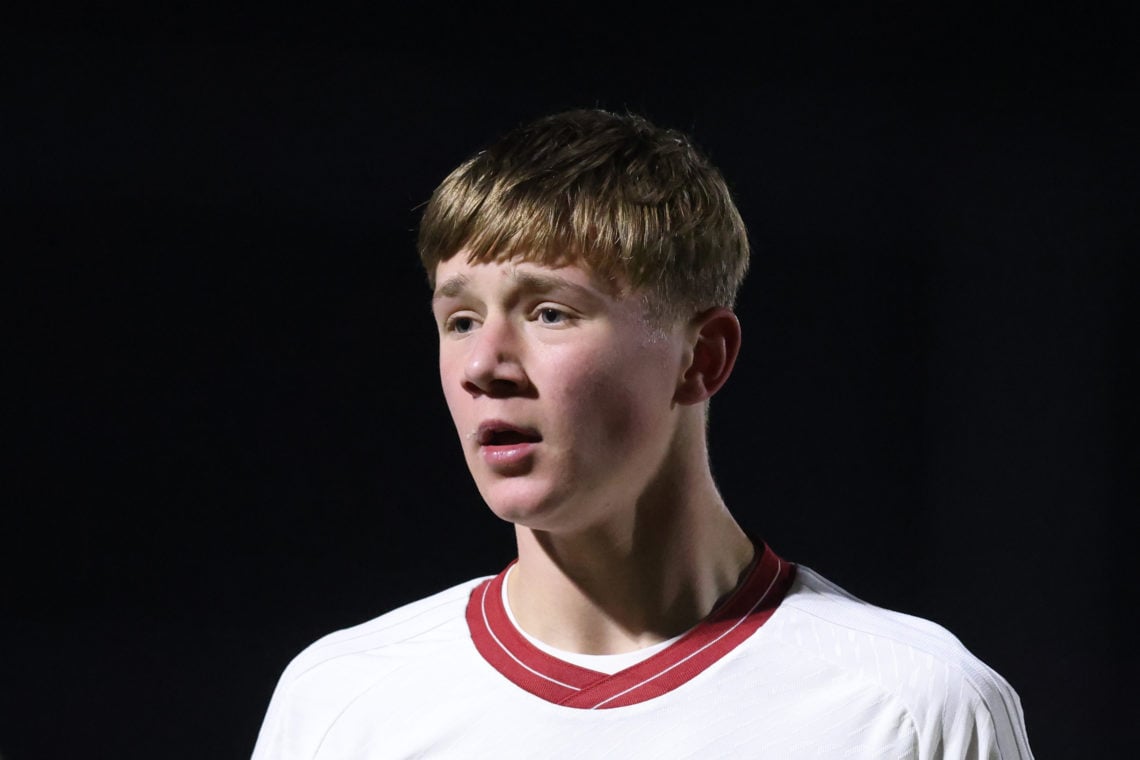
xmin=432 ymin=252 xmax=752 ymax=654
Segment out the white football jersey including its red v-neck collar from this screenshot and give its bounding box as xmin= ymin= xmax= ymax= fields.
xmin=253 ymin=546 xmax=1032 ymax=760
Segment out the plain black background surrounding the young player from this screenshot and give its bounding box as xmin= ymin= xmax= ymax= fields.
xmin=0 ymin=2 xmax=1140 ymax=760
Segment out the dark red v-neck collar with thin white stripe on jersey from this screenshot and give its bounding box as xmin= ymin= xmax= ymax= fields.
xmin=467 ymin=541 xmax=796 ymax=710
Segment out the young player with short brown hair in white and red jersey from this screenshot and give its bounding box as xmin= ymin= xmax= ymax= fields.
xmin=254 ymin=111 xmax=1031 ymax=760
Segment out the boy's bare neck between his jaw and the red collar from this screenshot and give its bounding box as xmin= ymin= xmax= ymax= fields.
xmin=507 ymin=430 xmax=754 ymax=654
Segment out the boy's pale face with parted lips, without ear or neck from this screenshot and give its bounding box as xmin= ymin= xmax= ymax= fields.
xmin=432 ymin=252 xmax=686 ymax=531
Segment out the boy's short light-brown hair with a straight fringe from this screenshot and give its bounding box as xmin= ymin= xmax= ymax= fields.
xmin=418 ymin=109 xmax=749 ymax=317
